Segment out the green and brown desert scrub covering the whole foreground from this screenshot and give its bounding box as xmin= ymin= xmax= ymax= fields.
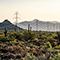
xmin=0 ymin=28 xmax=60 ymax=60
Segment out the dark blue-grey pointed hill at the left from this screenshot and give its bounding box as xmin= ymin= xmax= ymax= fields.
xmin=0 ymin=19 xmax=23 ymax=30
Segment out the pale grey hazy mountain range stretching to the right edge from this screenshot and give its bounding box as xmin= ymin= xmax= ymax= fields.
xmin=18 ymin=19 xmax=60 ymax=31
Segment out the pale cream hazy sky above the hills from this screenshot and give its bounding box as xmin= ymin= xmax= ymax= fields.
xmin=0 ymin=0 xmax=60 ymax=22
